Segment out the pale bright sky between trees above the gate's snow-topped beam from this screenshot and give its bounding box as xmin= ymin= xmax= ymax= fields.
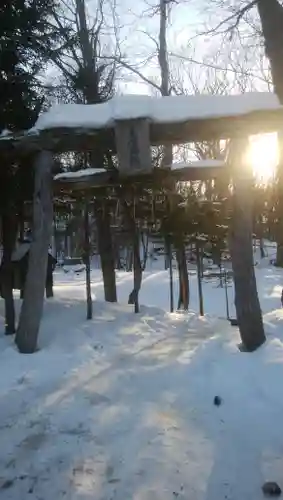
xmin=88 ymin=0 xmax=268 ymax=94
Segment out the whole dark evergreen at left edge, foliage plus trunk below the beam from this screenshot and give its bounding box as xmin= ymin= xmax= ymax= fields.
xmin=0 ymin=0 xmax=59 ymax=344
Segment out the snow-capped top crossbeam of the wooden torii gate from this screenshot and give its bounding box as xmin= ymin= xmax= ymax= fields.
xmin=0 ymin=92 xmax=283 ymax=173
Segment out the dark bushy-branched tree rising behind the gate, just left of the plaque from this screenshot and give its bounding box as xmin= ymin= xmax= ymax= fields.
xmin=51 ymin=0 xmax=117 ymax=302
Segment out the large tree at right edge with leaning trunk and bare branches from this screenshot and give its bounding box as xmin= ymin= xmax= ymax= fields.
xmin=199 ymin=0 xmax=283 ymax=267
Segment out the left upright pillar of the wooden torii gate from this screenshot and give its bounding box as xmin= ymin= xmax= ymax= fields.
xmin=15 ymin=151 xmax=53 ymax=353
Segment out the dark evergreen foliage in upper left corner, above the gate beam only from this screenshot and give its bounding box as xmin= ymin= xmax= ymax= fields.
xmin=0 ymin=0 xmax=56 ymax=132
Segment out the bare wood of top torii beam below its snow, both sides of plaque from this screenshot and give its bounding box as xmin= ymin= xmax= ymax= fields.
xmin=0 ymin=108 xmax=283 ymax=154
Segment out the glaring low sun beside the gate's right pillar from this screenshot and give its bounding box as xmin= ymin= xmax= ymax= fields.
xmin=248 ymin=134 xmax=278 ymax=183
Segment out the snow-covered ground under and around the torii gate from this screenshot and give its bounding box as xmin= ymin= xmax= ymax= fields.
xmin=0 ymin=248 xmax=283 ymax=500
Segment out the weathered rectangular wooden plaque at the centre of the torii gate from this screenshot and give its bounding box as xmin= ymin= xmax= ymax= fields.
xmin=115 ymin=118 xmax=152 ymax=175
